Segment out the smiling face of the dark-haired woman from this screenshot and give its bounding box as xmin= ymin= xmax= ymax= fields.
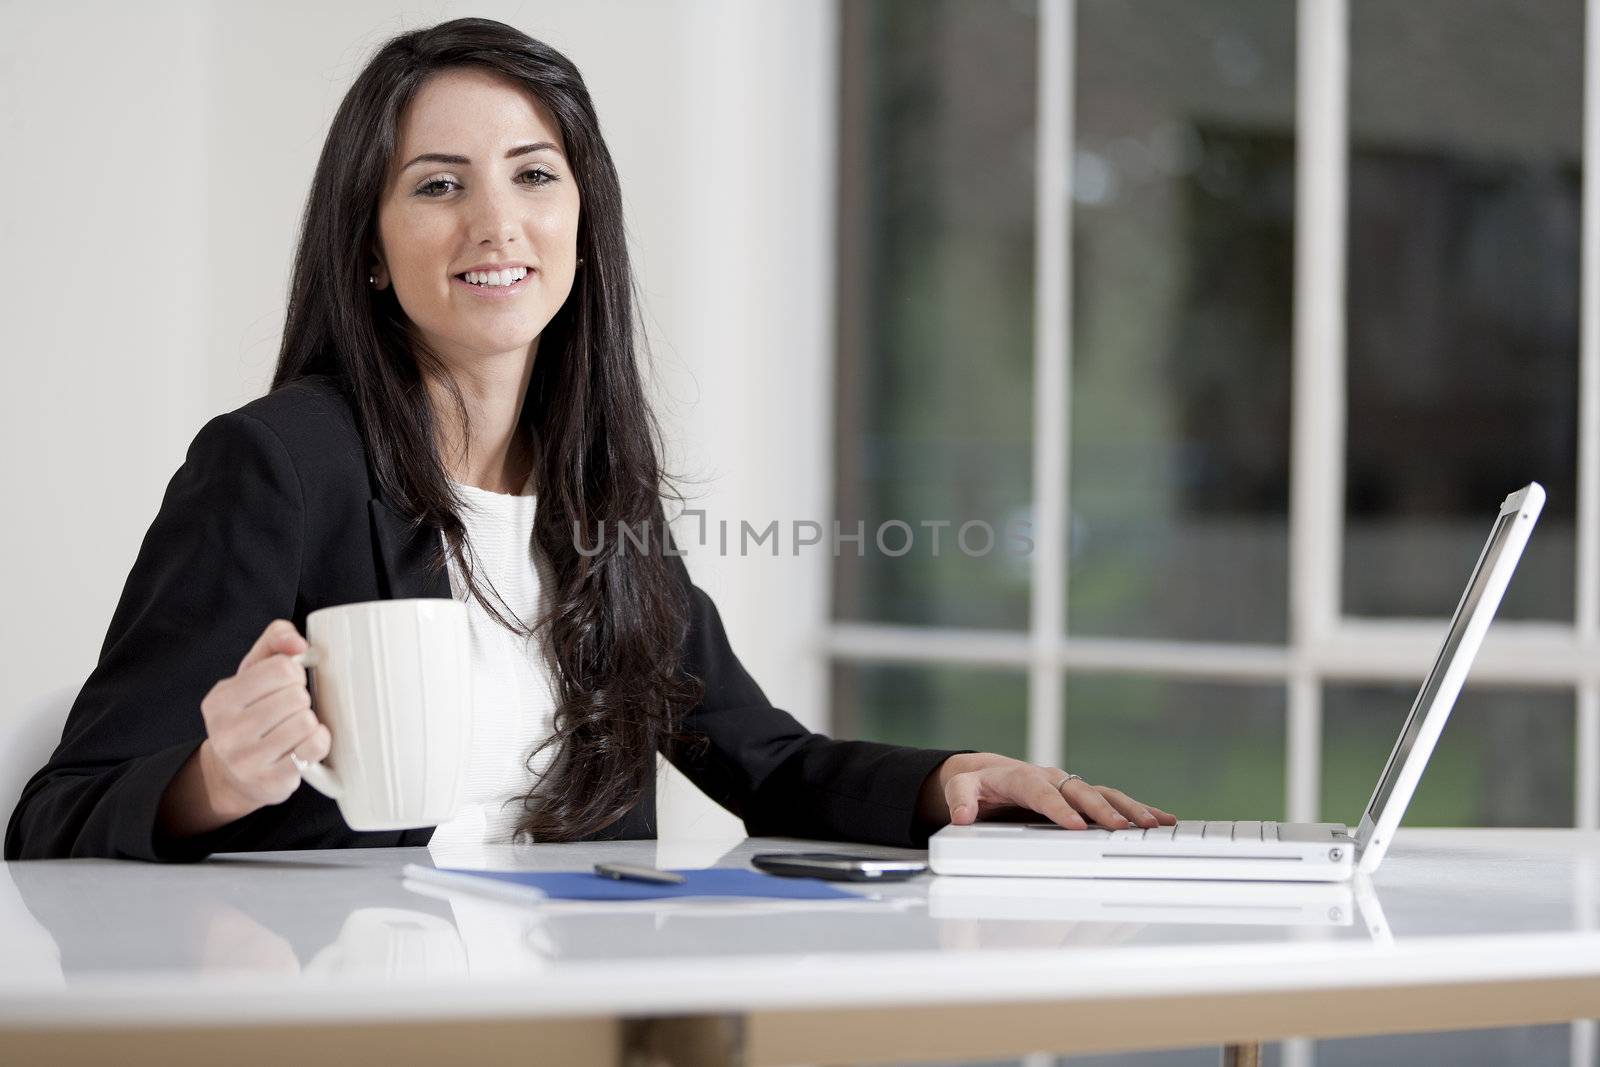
xmin=373 ymin=70 xmax=578 ymax=371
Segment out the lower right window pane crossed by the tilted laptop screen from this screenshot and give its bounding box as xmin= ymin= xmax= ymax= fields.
xmin=1322 ymin=685 xmax=1574 ymax=825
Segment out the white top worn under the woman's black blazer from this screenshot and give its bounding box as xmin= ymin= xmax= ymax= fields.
xmin=429 ymin=475 xmax=555 ymax=862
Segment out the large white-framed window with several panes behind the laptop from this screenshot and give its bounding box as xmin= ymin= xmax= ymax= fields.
xmin=827 ymin=0 xmax=1600 ymax=1059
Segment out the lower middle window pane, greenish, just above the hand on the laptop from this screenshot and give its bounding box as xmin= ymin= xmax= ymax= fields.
xmin=1061 ymin=675 xmax=1286 ymax=819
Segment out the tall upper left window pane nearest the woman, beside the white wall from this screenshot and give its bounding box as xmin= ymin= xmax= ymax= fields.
xmin=834 ymin=0 xmax=1037 ymax=629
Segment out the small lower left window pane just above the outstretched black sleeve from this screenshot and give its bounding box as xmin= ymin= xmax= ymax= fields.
xmin=834 ymin=662 xmax=1027 ymax=760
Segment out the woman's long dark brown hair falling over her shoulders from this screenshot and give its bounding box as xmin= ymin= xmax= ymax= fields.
xmin=272 ymin=18 xmax=704 ymax=840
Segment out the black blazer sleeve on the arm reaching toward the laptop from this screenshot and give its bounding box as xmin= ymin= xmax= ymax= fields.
xmin=667 ymin=555 xmax=971 ymax=848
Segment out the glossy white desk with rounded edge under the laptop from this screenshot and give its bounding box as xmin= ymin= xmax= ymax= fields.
xmin=0 ymin=830 xmax=1600 ymax=1067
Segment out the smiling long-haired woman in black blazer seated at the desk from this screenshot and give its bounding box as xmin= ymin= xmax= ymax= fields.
xmin=5 ymin=19 xmax=1173 ymax=861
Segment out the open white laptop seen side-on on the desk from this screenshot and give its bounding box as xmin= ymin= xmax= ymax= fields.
xmin=928 ymin=482 xmax=1544 ymax=881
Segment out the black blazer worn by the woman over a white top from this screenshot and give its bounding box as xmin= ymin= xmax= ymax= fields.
xmin=5 ymin=376 xmax=952 ymax=861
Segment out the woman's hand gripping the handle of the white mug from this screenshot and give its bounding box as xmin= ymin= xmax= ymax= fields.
xmin=200 ymin=619 xmax=333 ymax=811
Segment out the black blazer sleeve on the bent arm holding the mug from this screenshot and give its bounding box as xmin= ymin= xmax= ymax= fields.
xmin=5 ymin=411 xmax=390 ymax=861
